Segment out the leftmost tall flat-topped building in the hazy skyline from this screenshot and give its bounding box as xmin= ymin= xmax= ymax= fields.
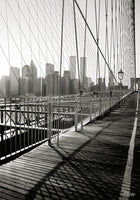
xmin=10 ymin=67 xmax=20 ymax=97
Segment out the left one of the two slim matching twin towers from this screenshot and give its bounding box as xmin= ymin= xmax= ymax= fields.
xmin=69 ymin=56 xmax=76 ymax=79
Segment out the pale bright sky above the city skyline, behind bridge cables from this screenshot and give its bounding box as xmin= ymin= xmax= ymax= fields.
xmin=0 ymin=0 xmax=136 ymax=90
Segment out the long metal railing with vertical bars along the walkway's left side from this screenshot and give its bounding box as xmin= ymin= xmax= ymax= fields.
xmin=0 ymin=92 xmax=132 ymax=160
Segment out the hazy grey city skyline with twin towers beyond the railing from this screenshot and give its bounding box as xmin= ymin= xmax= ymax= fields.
xmin=0 ymin=56 xmax=92 ymax=97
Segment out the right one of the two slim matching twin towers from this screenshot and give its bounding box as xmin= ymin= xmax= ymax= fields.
xmin=80 ymin=57 xmax=87 ymax=88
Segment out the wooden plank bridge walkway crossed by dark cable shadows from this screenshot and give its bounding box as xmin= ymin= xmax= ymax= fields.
xmin=0 ymin=95 xmax=140 ymax=200
